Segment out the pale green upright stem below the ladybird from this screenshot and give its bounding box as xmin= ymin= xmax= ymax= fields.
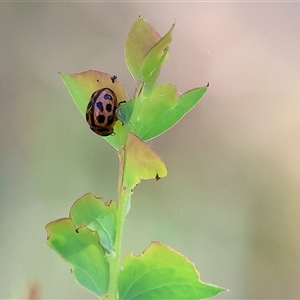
xmin=107 ymin=148 xmax=130 ymax=300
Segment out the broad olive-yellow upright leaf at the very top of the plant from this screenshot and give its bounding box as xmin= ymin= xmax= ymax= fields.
xmin=125 ymin=18 xmax=160 ymax=80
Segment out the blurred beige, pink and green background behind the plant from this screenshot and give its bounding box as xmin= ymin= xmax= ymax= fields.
xmin=0 ymin=2 xmax=300 ymax=299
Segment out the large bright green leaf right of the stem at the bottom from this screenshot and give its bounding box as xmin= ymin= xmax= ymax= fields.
xmin=119 ymin=242 xmax=225 ymax=300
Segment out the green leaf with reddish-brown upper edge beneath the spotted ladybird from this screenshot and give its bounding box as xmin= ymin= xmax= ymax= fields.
xmin=60 ymin=70 xmax=129 ymax=149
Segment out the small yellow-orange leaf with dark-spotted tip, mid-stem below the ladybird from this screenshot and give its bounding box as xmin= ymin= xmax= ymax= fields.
xmin=124 ymin=133 xmax=168 ymax=190
